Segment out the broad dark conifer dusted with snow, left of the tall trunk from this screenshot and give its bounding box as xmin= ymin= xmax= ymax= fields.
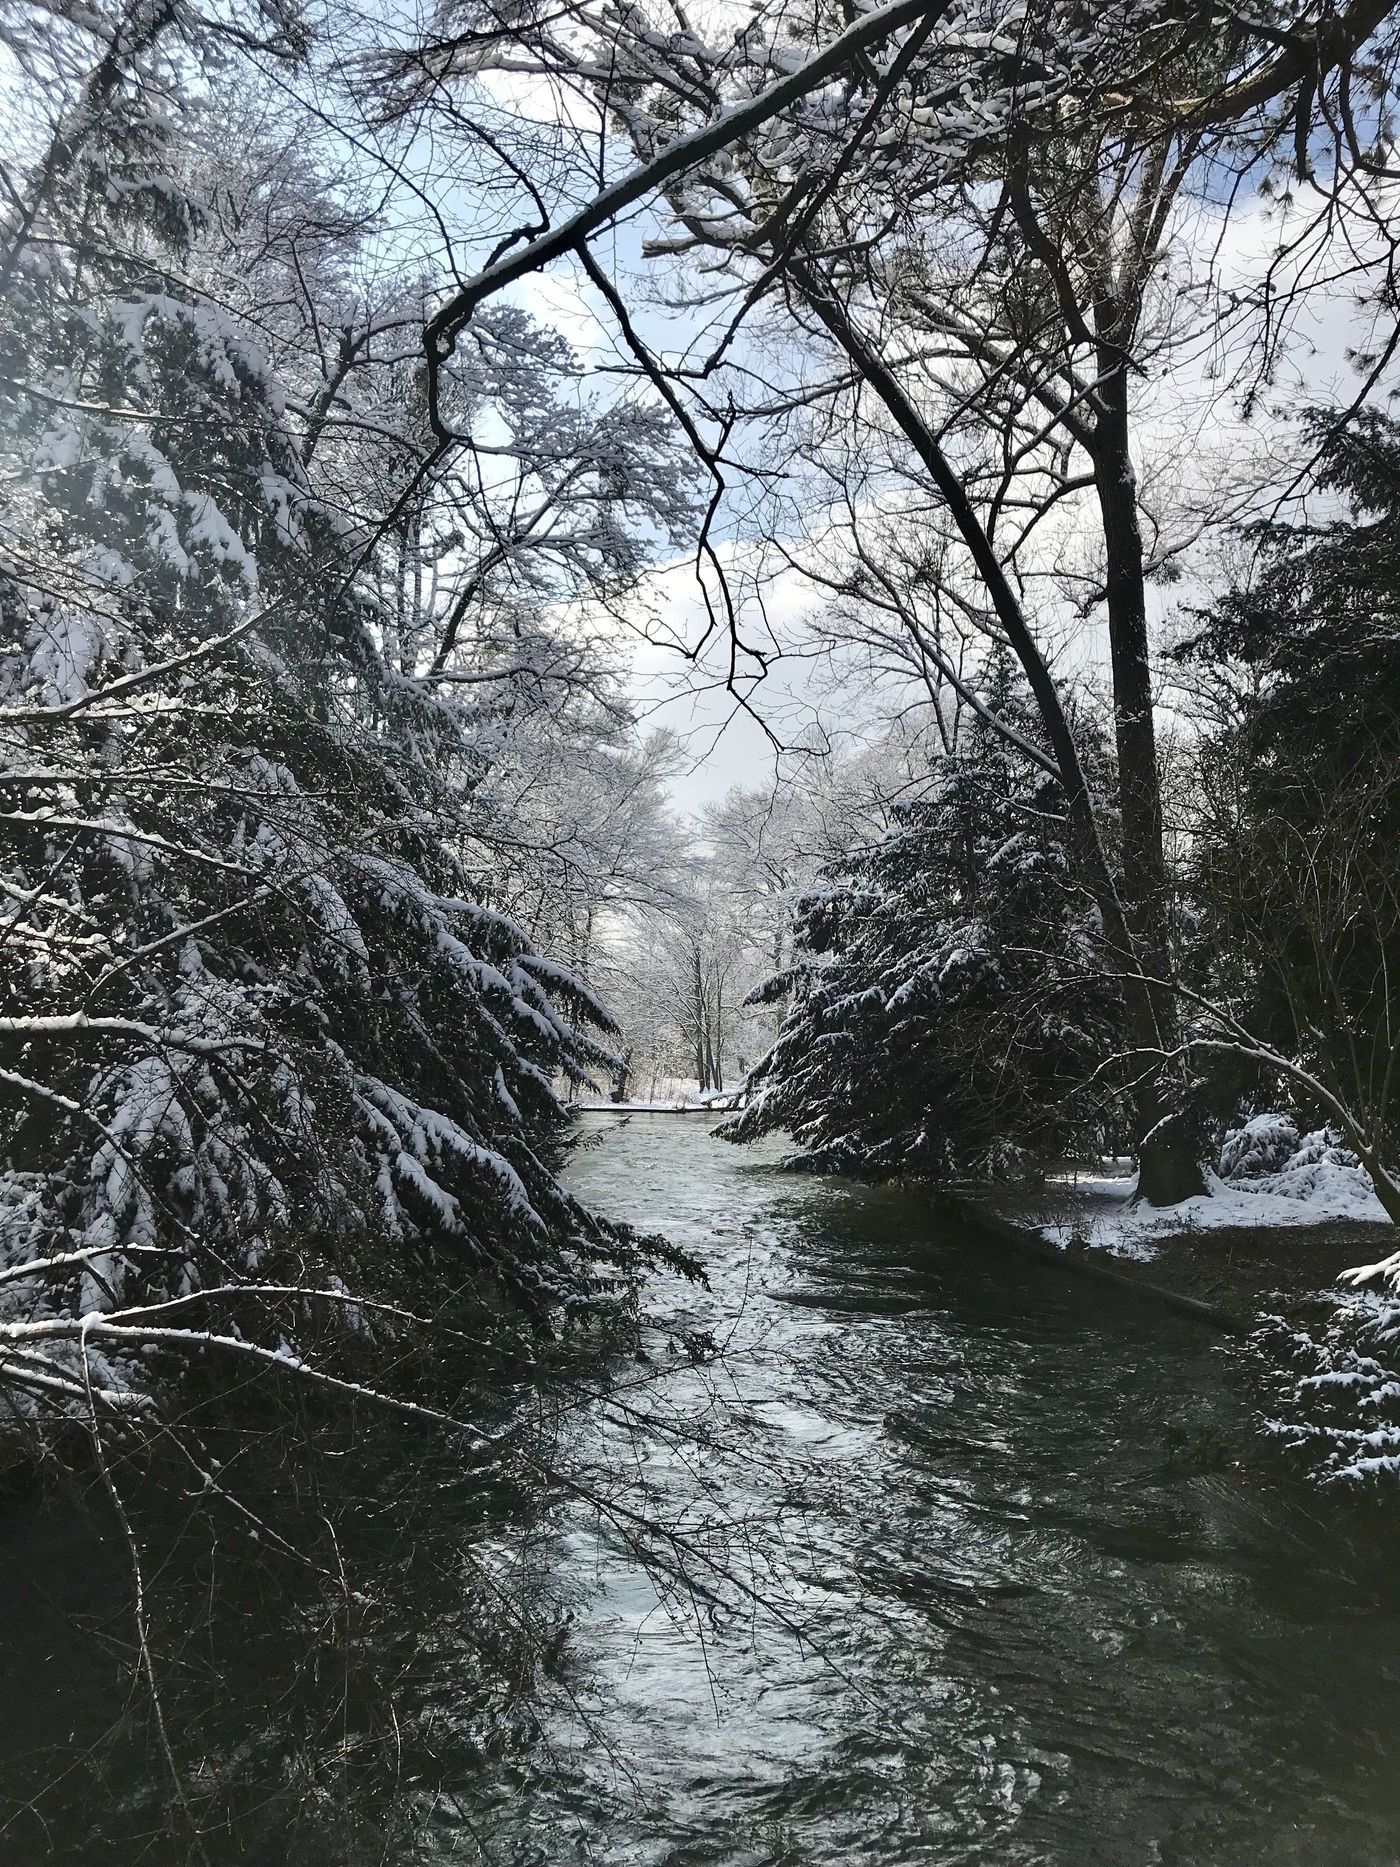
xmin=730 ymin=657 xmax=1122 ymax=1178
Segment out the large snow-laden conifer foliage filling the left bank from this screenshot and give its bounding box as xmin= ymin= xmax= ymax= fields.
xmin=0 ymin=7 xmax=690 ymax=1391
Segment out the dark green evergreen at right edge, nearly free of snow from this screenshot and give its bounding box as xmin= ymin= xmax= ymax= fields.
xmin=1180 ymin=413 xmax=1400 ymax=1163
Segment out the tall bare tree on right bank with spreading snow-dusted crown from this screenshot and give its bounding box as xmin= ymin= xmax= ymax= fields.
xmin=398 ymin=0 xmax=1396 ymax=1204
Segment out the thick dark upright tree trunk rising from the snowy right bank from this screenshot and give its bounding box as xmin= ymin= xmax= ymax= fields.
xmin=1094 ymin=341 xmax=1206 ymax=1206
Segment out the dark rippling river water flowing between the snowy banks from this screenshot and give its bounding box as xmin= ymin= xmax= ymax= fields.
xmin=0 ymin=1116 xmax=1400 ymax=1867
